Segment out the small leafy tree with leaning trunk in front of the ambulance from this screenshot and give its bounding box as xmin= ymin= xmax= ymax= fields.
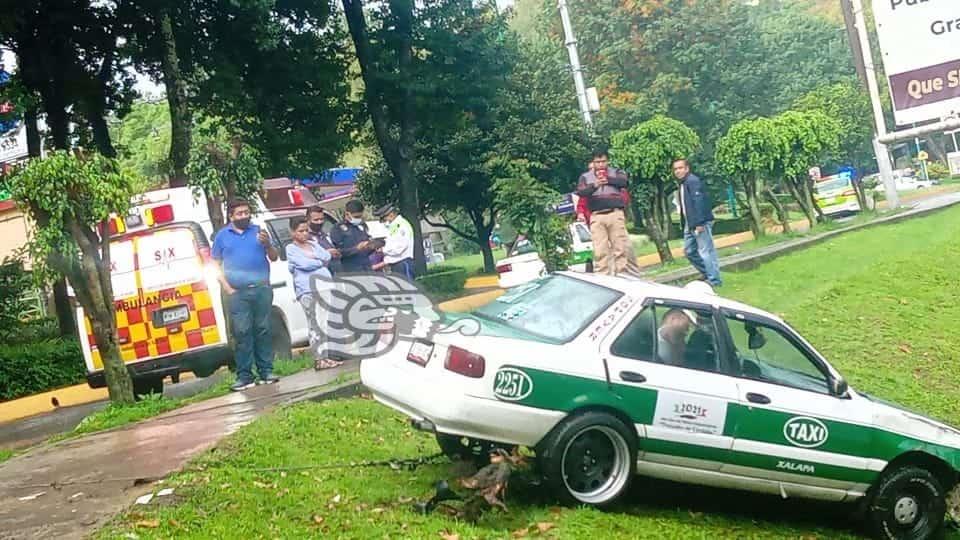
xmin=6 ymin=150 xmax=135 ymax=403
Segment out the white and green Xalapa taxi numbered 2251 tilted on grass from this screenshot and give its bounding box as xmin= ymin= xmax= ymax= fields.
xmin=360 ymin=272 xmax=960 ymax=539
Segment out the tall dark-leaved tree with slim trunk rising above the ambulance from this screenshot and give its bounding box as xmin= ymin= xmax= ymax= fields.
xmin=125 ymin=0 xmax=355 ymax=181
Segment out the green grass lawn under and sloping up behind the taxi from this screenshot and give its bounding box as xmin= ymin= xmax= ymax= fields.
xmin=99 ymin=208 xmax=960 ymax=540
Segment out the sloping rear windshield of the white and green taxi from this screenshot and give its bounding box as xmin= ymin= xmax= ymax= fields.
xmin=473 ymin=275 xmax=622 ymax=343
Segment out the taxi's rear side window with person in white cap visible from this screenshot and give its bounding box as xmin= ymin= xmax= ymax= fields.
xmin=611 ymin=305 xmax=720 ymax=372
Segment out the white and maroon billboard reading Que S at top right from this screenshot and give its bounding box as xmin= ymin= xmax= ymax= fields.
xmin=873 ymin=0 xmax=960 ymax=126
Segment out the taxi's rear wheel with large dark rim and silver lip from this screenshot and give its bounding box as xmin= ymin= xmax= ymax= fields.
xmin=537 ymin=412 xmax=637 ymax=507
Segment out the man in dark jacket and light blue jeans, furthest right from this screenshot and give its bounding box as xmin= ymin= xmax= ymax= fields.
xmin=673 ymin=159 xmax=723 ymax=287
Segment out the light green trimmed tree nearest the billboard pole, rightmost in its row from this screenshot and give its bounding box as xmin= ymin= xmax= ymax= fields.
xmin=792 ymin=79 xmax=876 ymax=208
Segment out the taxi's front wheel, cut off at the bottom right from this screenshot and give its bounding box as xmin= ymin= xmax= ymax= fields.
xmin=867 ymin=465 xmax=947 ymax=540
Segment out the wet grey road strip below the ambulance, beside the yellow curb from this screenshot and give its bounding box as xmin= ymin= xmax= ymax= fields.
xmin=0 ymin=369 xmax=230 ymax=452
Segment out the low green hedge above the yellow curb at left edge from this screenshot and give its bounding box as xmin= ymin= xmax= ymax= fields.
xmin=0 ymin=339 xmax=86 ymax=401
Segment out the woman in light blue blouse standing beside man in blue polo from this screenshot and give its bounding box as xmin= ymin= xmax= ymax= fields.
xmin=287 ymin=217 xmax=342 ymax=370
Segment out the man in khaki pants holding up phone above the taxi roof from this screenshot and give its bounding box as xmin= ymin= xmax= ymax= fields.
xmin=577 ymin=150 xmax=633 ymax=275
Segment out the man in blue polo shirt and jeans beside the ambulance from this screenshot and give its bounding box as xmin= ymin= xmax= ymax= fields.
xmin=212 ymin=201 xmax=278 ymax=392
